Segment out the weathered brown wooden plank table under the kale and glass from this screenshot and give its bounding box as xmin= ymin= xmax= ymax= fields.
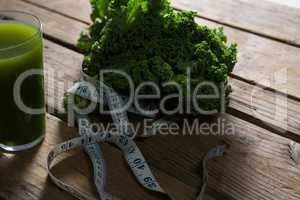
xmin=0 ymin=0 xmax=300 ymax=200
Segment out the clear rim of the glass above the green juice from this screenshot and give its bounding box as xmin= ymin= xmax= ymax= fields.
xmin=0 ymin=9 xmax=43 ymax=52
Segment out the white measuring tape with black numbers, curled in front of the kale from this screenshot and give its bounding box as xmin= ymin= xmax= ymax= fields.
xmin=47 ymin=74 xmax=225 ymax=200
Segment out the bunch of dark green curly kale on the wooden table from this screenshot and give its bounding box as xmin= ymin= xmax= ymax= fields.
xmin=78 ymin=0 xmax=237 ymax=113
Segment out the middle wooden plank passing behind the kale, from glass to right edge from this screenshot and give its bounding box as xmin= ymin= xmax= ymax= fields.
xmin=44 ymin=40 xmax=300 ymax=141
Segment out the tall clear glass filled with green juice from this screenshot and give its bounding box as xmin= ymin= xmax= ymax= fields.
xmin=0 ymin=10 xmax=45 ymax=152
